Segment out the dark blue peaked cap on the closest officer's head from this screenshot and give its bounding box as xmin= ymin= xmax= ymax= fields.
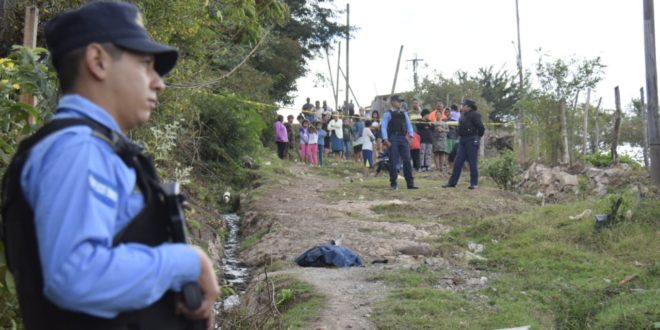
xmin=45 ymin=1 xmax=179 ymax=76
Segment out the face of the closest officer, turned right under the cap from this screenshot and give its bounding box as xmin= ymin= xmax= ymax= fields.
xmin=108 ymin=51 xmax=165 ymax=131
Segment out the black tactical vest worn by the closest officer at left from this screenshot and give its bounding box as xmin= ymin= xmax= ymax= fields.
xmin=2 ymin=118 xmax=190 ymax=330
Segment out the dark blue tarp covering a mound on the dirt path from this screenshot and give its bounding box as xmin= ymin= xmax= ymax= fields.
xmin=296 ymin=244 xmax=363 ymax=267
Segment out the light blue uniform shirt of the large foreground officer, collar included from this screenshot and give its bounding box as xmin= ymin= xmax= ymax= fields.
xmin=21 ymin=95 xmax=201 ymax=318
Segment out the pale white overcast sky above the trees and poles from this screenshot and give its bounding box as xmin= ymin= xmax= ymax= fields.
xmin=293 ymin=0 xmax=660 ymax=115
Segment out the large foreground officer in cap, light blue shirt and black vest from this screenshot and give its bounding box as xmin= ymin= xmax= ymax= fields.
xmin=3 ymin=2 xmax=219 ymax=330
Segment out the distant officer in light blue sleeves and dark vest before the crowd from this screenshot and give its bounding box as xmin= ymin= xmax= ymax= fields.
xmin=380 ymin=95 xmax=418 ymax=190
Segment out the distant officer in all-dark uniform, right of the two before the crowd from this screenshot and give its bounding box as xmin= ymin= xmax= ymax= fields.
xmin=442 ymin=99 xmax=486 ymax=189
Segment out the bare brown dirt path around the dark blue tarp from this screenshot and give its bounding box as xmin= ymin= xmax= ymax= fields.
xmin=242 ymin=165 xmax=528 ymax=329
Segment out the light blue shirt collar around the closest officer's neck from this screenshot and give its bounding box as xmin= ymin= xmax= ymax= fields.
xmin=53 ymin=94 xmax=124 ymax=135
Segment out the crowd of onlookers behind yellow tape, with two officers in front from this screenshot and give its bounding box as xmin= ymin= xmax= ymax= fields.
xmin=275 ymin=95 xmax=484 ymax=189
